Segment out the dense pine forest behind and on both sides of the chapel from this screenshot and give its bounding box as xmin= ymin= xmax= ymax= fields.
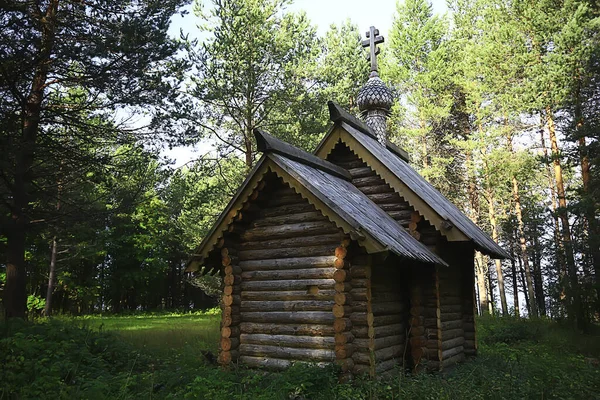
xmin=0 ymin=0 xmax=600 ymax=328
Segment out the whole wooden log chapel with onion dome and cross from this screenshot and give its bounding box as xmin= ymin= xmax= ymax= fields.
xmin=188 ymin=28 xmax=509 ymax=376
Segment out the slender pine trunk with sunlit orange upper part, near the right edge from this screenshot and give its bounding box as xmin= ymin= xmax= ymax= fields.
xmin=546 ymin=108 xmax=585 ymax=329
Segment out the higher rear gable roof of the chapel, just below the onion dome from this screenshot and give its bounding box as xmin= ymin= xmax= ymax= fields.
xmin=315 ymin=102 xmax=510 ymax=258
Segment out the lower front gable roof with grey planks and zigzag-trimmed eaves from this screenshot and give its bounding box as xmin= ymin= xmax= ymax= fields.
xmin=187 ymin=130 xmax=448 ymax=271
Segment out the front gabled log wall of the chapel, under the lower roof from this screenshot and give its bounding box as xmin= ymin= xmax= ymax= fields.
xmin=219 ymin=174 xmax=346 ymax=370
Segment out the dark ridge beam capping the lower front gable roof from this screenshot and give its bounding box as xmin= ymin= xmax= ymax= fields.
xmin=254 ymin=128 xmax=352 ymax=181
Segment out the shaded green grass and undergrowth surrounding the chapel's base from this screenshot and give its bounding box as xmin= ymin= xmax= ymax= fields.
xmin=0 ymin=313 xmax=600 ymax=400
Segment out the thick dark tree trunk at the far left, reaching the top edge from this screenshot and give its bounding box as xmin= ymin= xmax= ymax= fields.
xmin=4 ymin=0 xmax=58 ymax=318
